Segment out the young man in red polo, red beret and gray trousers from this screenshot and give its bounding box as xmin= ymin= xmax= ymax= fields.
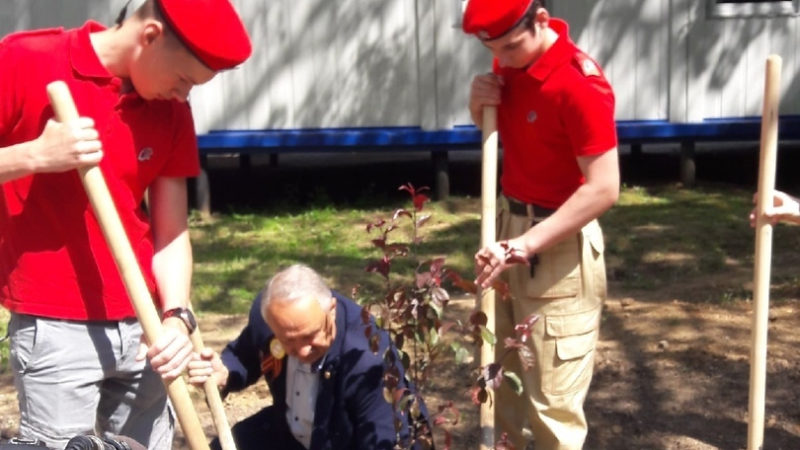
xmin=0 ymin=0 xmax=251 ymax=449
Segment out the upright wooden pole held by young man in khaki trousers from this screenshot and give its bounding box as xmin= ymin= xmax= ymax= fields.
xmin=478 ymin=106 xmax=497 ymax=450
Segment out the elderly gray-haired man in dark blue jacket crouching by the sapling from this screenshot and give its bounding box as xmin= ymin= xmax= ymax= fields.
xmin=189 ymin=265 xmax=430 ymax=450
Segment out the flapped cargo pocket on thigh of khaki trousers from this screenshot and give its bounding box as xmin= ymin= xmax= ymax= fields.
xmin=542 ymin=308 xmax=601 ymax=395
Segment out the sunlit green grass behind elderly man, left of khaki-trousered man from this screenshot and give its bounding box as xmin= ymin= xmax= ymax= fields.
xmin=191 ymin=199 xmax=480 ymax=313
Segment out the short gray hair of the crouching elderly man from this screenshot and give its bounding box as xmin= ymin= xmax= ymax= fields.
xmin=261 ymin=264 xmax=333 ymax=315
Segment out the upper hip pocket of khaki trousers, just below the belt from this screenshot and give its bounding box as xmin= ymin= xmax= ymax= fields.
xmin=516 ymin=234 xmax=581 ymax=299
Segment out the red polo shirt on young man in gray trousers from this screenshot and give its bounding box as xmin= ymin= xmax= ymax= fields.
xmin=0 ymin=21 xmax=199 ymax=320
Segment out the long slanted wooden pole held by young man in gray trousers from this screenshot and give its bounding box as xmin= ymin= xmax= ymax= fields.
xmin=47 ymin=81 xmax=209 ymax=450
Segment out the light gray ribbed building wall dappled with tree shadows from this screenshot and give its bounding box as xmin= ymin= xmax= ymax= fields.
xmin=0 ymin=0 xmax=800 ymax=133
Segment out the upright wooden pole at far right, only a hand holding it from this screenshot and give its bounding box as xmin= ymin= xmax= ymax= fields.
xmin=747 ymin=55 xmax=781 ymax=450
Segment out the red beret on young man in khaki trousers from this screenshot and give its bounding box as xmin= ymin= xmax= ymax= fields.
xmin=461 ymin=0 xmax=533 ymax=41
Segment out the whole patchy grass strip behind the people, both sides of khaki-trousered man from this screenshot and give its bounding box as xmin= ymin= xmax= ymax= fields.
xmin=192 ymin=181 xmax=800 ymax=313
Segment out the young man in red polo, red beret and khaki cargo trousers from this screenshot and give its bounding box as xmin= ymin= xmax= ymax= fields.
xmin=463 ymin=0 xmax=619 ymax=449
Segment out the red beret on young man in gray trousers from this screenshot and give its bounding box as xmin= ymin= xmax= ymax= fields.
xmin=156 ymin=0 xmax=253 ymax=71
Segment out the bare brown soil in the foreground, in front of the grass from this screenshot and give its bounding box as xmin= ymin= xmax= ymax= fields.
xmin=0 ymin=294 xmax=800 ymax=450
